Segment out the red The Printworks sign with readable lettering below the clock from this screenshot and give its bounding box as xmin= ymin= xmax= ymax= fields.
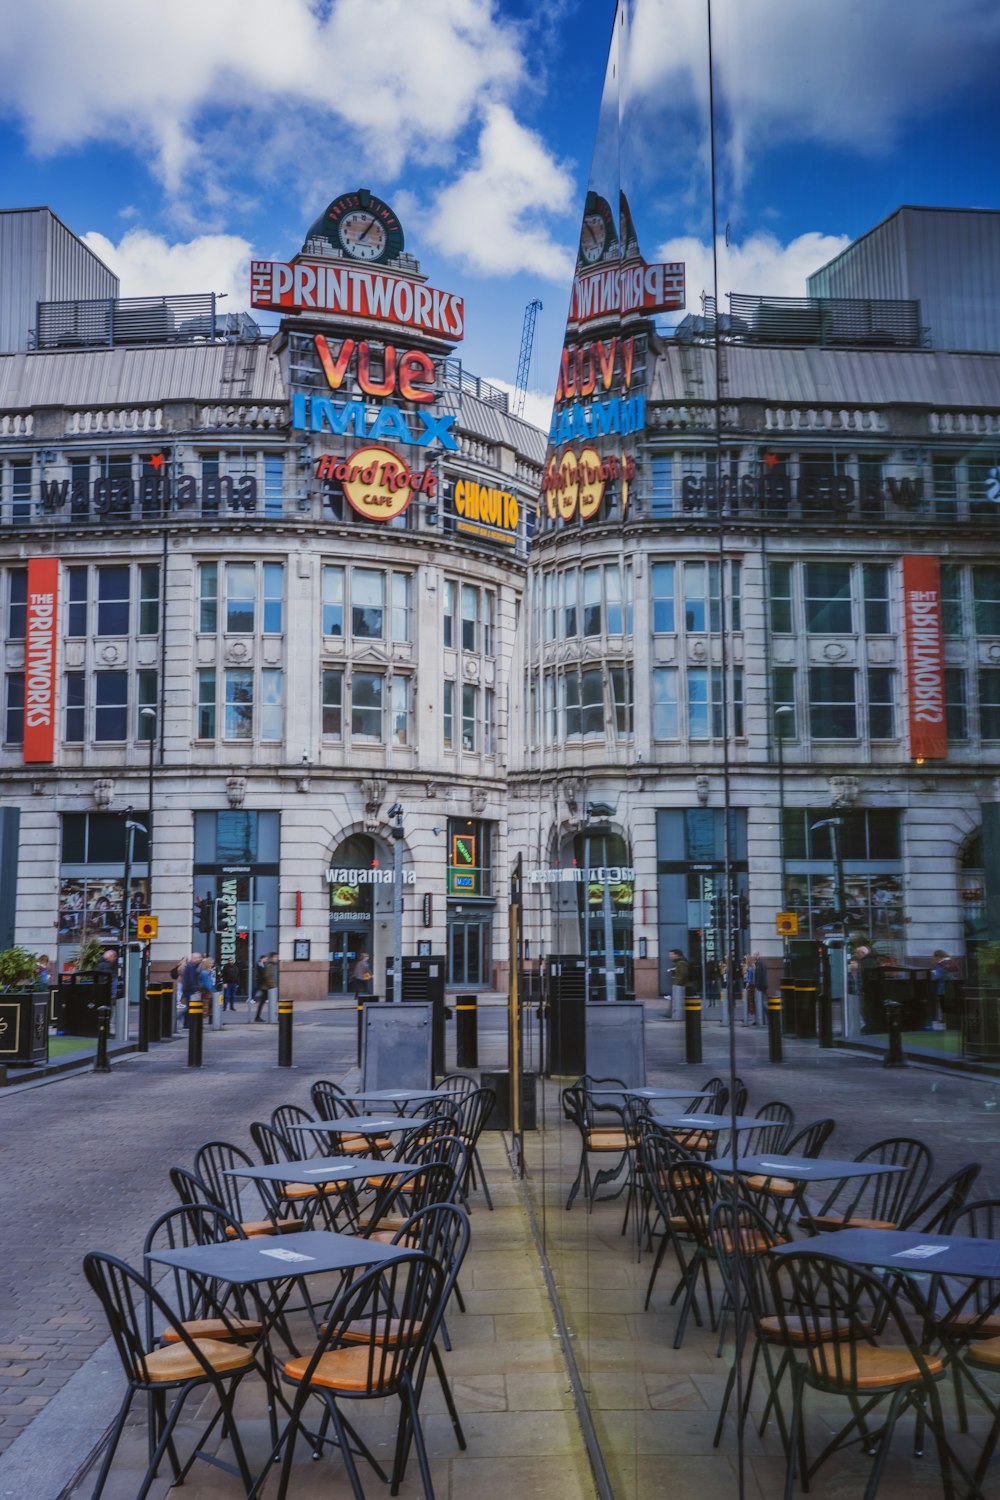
xmin=250 ymin=261 xmax=465 ymax=342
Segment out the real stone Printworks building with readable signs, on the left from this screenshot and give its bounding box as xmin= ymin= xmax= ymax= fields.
xmin=0 ymin=191 xmax=544 ymax=999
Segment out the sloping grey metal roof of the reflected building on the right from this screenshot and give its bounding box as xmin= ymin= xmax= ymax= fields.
xmin=648 ymin=344 xmax=1000 ymax=411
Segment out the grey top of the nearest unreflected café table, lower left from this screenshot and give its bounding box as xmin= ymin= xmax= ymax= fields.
xmin=150 ymin=1230 xmax=409 ymax=1287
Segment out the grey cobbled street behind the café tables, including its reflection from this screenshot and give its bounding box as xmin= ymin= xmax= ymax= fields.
xmin=0 ymin=1005 xmax=1000 ymax=1482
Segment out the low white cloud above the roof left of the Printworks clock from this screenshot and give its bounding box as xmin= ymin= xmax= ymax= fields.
xmin=82 ymin=230 xmax=252 ymax=303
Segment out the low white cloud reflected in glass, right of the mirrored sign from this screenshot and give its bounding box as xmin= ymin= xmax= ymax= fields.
xmin=654 ymin=231 xmax=850 ymax=314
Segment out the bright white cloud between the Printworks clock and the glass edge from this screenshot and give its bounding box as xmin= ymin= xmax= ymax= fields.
xmin=423 ymin=104 xmax=576 ymax=287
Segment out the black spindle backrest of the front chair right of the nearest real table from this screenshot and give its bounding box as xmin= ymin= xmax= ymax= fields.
xmin=301 ymin=1251 xmax=447 ymax=1397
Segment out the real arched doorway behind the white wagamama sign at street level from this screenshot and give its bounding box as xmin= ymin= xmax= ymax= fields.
xmin=327 ymin=834 xmax=393 ymax=995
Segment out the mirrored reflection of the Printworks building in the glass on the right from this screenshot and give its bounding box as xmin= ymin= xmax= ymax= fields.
xmin=511 ymin=199 xmax=1000 ymax=1020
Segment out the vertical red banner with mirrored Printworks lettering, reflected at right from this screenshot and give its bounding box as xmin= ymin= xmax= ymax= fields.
xmin=903 ymin=557 xmax=948 ymax=761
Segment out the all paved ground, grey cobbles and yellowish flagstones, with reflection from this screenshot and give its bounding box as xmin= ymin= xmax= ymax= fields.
xmin=0 ymin=1007 xmax=1000 ymax=1500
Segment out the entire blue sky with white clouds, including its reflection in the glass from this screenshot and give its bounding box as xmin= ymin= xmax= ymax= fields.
xmin=0 ymin=0 xmax=1000 ymax=423
